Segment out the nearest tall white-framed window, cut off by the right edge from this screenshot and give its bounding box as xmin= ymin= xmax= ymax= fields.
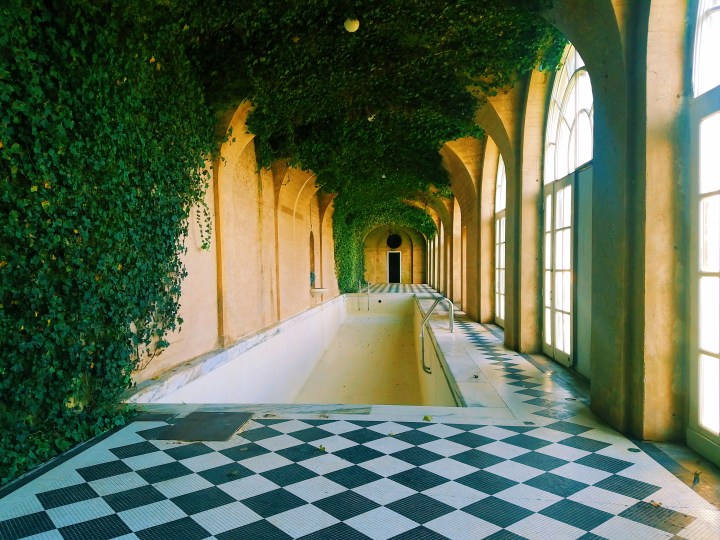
xmin=688 ymin=0 xmax=720 ymax=451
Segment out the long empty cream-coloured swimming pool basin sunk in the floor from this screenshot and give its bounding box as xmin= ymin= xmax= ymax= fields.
xmin=131 ymin=294 xmax=456 ymax=406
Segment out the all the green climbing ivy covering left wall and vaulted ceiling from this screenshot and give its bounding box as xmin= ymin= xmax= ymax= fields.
xmin=0 ymin=0 xmax=562 ymax=481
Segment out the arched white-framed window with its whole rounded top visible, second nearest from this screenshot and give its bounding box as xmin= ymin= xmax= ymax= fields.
xmin=543 ymin=45 xmax=593 ymax=364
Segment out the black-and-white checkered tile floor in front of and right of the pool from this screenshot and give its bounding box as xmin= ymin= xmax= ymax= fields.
xmin=0 ymin=298 xmax=720 ymax=540
